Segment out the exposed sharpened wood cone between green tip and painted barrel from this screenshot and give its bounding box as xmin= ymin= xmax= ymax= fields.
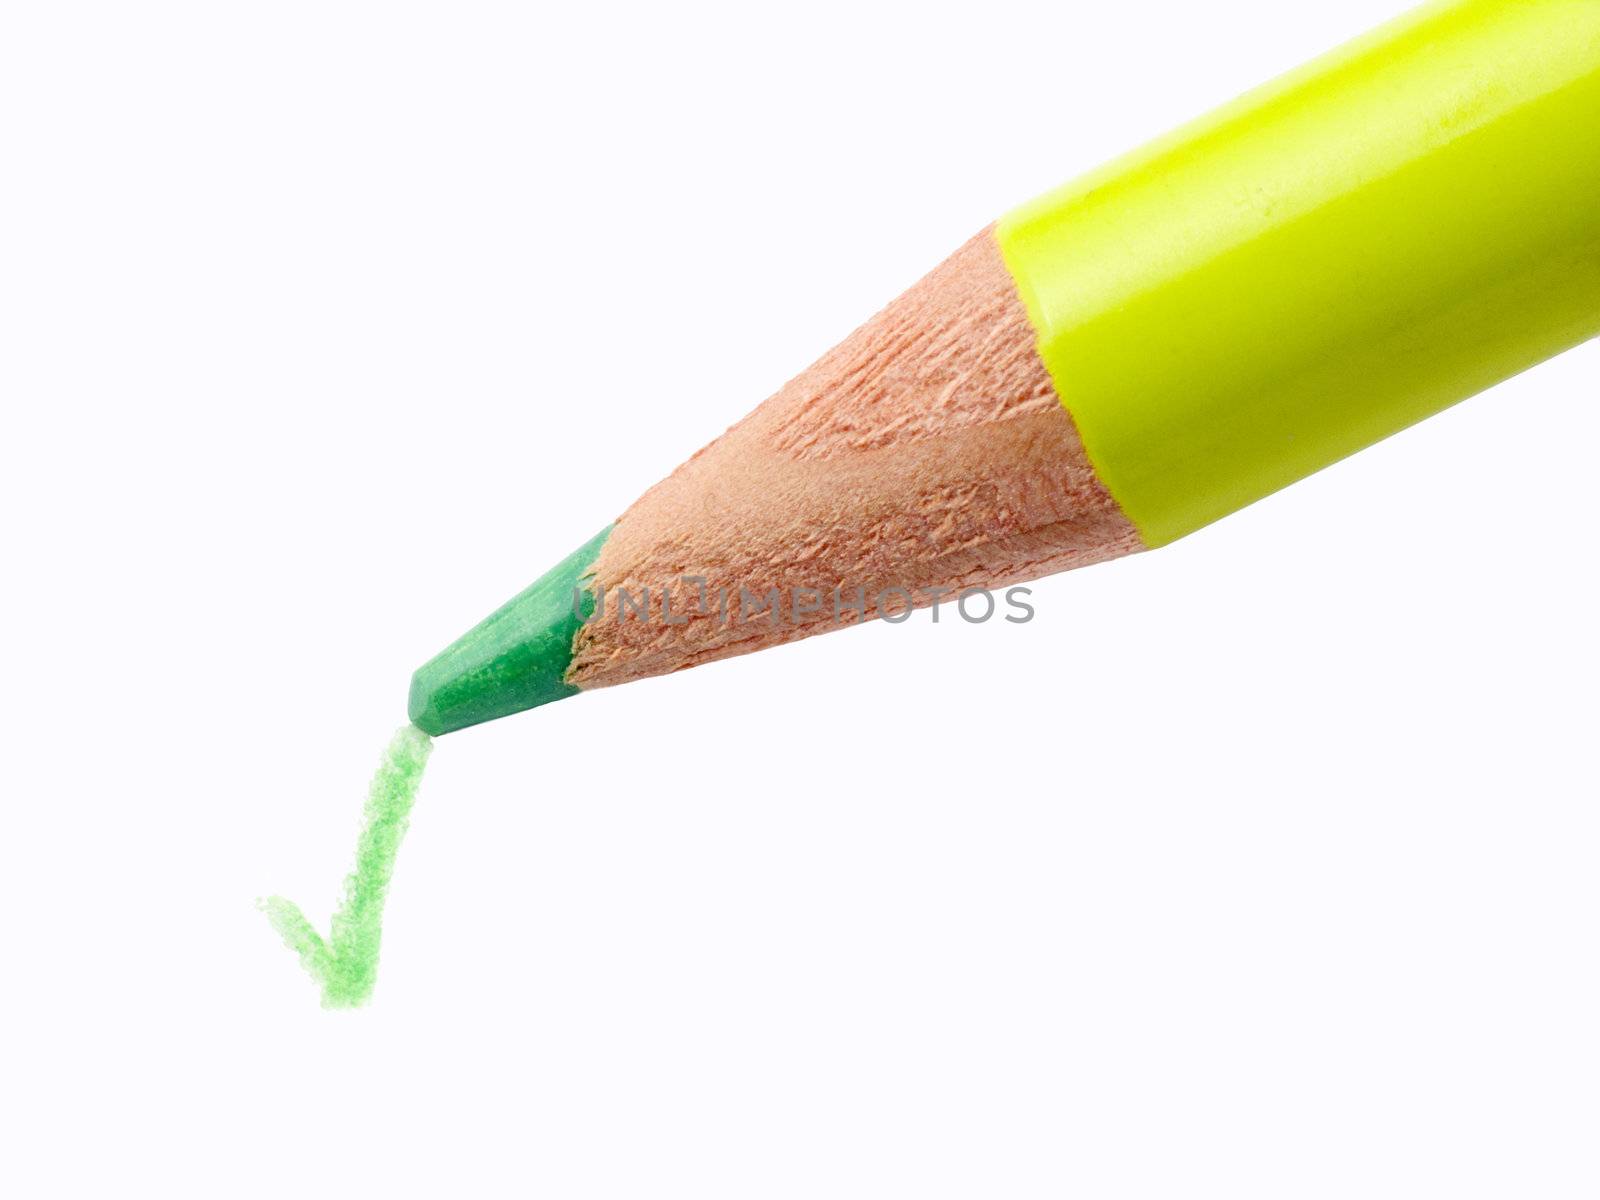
xmin=568 ymin=229 xmax=1142 ymax=688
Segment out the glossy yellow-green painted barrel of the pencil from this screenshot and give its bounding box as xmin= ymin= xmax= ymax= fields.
xmin=998 ymin=0 xmax=1600 ymax=546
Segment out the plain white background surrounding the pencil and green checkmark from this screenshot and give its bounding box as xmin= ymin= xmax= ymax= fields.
xmin=0 ymin=0 xmax=1600 ymax=1200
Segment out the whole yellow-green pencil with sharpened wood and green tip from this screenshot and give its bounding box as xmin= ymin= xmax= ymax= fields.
xmin=410 ymin=0 xmax=1600 ymax=734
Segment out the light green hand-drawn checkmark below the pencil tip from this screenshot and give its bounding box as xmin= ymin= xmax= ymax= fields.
xmin=261 ymin=725 xmax=434 ymax=1008
